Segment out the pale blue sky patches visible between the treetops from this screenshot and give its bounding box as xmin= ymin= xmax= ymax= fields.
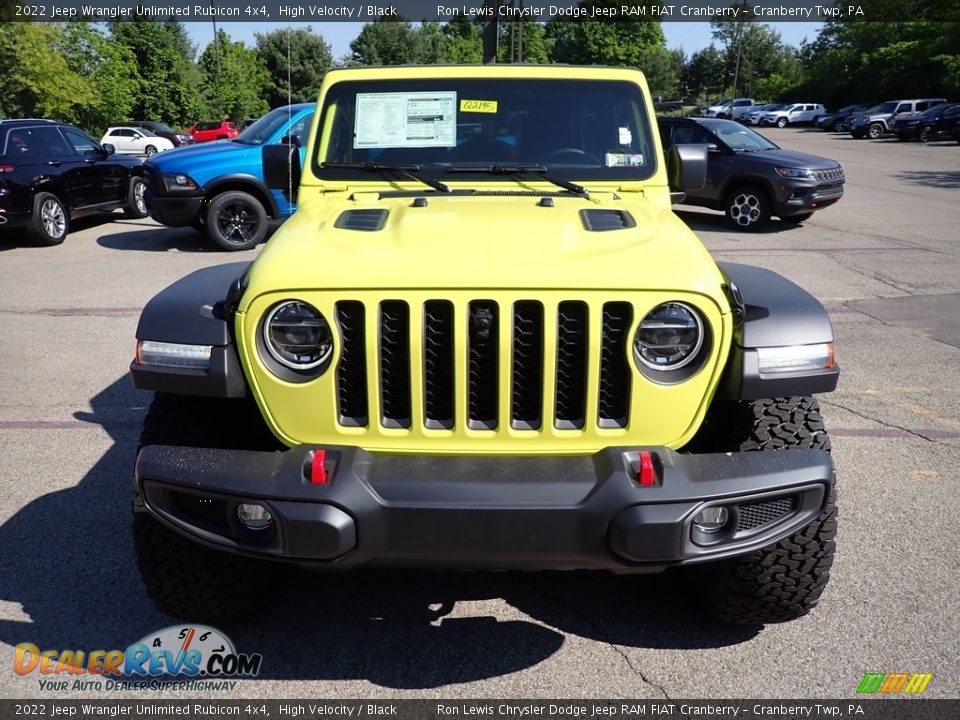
xmin=184 ymin=22 xmax=822 ymax=59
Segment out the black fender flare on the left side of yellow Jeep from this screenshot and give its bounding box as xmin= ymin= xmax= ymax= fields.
xmin=130 ymin=261 xmax=250 ymax=398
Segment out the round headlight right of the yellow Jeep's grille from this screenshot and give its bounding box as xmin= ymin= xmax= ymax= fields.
xmin=633 ymin=302 xmax=703 ymax=370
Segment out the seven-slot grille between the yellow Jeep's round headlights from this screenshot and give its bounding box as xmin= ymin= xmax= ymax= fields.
xmin=336 ymin=300 xmax=633 ymax=430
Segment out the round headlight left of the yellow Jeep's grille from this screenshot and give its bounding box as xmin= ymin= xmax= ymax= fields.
xmin=263 ymin=300 xmax=333 ymax=370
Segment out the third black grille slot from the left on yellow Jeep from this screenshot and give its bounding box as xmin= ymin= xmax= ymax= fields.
xmin=423 ymin=300 xmax=454 ymax=429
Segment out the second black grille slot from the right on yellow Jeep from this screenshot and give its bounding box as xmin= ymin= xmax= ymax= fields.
xmin=554 ymin=301 xmax=588 ymax=430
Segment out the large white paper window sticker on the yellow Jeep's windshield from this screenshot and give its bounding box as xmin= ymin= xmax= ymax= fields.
xmin=353 ymin=91 xmax=457 ymax=150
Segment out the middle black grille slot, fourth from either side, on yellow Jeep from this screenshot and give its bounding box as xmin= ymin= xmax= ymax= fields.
xmin=467 ymin=300 xmax=500 ymax=430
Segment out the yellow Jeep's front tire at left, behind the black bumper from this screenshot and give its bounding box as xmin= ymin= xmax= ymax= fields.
xmin=133 ymin=393 xmax=281 ymax=622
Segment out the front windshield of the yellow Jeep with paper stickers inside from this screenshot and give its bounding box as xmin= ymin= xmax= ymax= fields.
xmin=313 ymin=78 xmax=656 ymax=181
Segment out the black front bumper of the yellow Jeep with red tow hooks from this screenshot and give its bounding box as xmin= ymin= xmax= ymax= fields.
xmin=135 ymin=445 xmax=833 ymax=572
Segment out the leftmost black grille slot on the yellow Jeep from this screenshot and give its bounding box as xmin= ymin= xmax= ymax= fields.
xmin=336 ymin=300 xmax=369 ymax=427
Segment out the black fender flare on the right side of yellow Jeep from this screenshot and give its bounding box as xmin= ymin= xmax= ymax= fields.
xmin=717 ymin=262 xmax=840 ymax=400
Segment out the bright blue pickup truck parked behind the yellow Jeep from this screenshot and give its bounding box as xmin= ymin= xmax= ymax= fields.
xmin=144 ymin=103 xmax=316 ymax=250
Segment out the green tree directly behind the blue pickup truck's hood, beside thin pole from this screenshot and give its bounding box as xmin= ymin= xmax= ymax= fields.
xmin=199 ymin=30 xmax=271 ymax=121
